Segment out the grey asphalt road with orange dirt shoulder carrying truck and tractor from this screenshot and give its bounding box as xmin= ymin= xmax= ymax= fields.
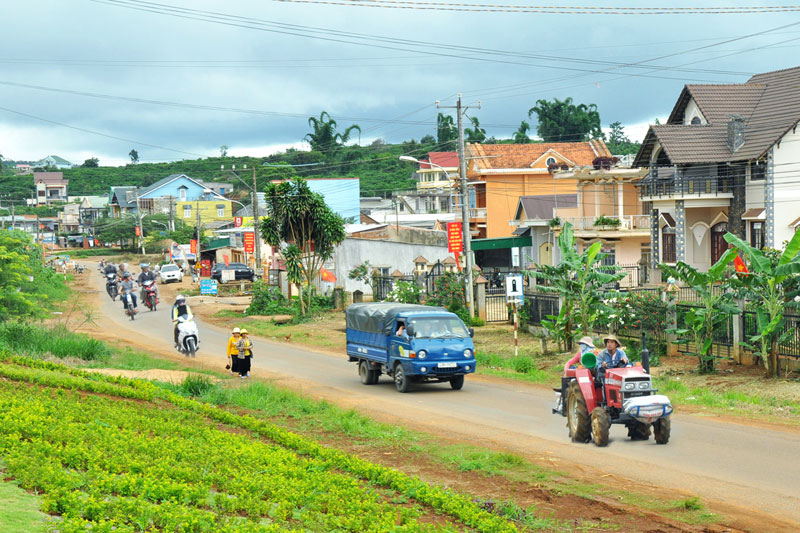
xmin=91 ymin=269 xmax=800 ymax=531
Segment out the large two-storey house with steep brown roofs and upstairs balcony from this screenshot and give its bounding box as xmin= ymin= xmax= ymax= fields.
xmin=634 ymin=67 xmax=800 ymax=270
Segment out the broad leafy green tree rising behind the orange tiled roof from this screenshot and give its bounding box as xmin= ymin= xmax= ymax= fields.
xmin=528 ymin=97 xmax=604 ymax=142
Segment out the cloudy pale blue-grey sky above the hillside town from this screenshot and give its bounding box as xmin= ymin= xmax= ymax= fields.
xmin=0 ymin=0 xmax=800 ymax=165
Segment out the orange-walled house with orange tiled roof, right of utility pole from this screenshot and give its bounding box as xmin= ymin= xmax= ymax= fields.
xmin=466 ymin=140 xmax=611 ymax=239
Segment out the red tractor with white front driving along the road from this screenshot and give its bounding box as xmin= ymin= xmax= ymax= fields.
xmin=553 ymin=344 xmax=672 ymax=446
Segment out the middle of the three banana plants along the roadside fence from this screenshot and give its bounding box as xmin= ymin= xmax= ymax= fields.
xmin=659 ymin=249 xmax=740 ymax=374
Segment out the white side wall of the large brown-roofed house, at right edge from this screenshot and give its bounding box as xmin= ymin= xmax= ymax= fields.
xmin=767 ymin=127 xmax=800 ymax=248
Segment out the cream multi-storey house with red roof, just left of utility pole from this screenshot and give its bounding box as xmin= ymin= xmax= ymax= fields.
xmin=393 ymin=152 xmax=459 ymax=214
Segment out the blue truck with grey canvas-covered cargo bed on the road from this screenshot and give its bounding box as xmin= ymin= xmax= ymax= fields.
xmin=345 ymin=303 xmax=475 ymax=392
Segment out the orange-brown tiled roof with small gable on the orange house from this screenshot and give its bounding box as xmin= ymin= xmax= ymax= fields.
xmin=467 ymin=140 xmax=611 ymax=171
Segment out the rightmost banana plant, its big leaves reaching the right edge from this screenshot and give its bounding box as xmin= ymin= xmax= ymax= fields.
xmin=725 ymin=231 xmax=800 ymax=378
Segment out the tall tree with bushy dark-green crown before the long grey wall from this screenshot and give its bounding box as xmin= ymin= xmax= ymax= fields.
xmin=261 ymin=178 xmax=346 ymax=314
